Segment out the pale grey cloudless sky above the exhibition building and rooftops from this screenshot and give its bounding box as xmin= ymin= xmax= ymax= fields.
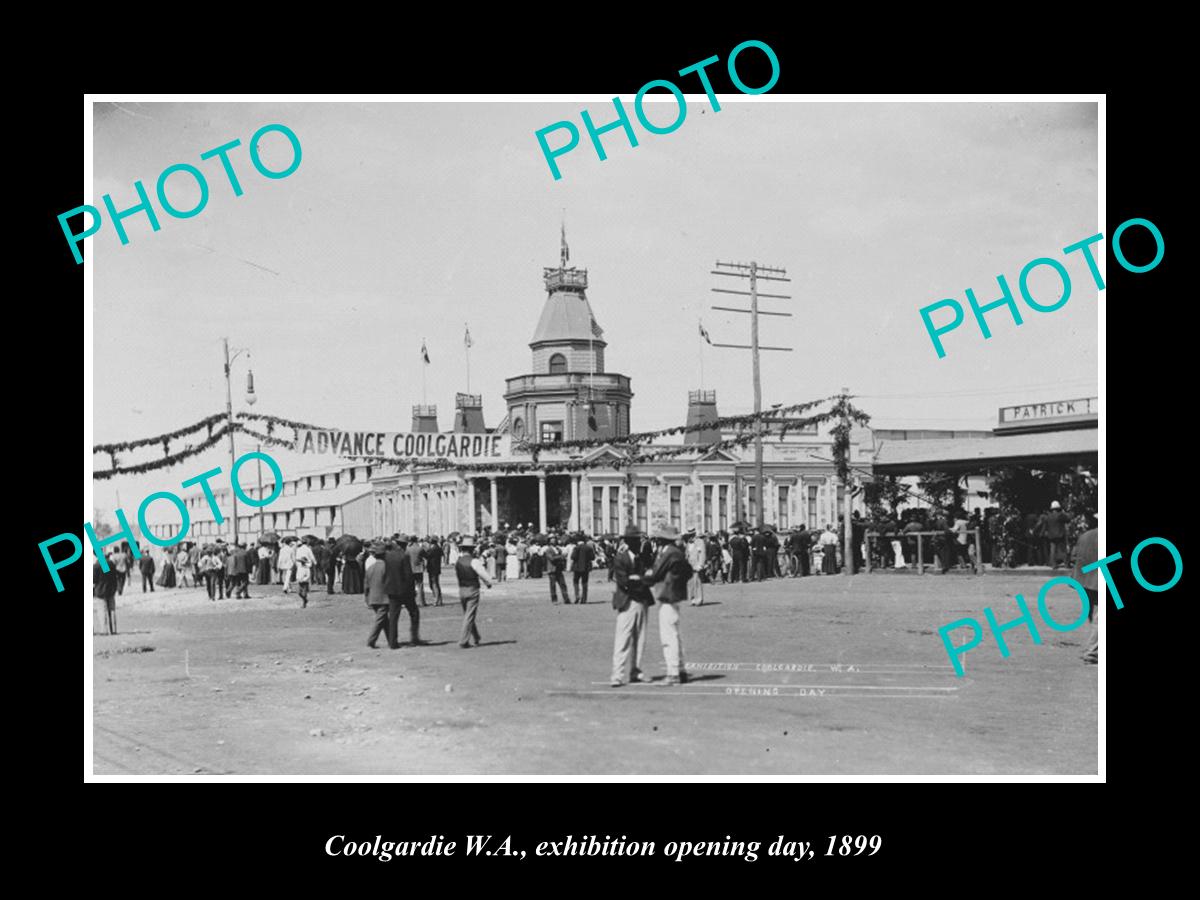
xmin=85 ymin=95 xmax=1103 ymax=515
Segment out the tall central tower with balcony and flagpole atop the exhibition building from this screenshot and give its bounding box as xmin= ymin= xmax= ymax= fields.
xmin=504 ymin=228 xmax=634 ymax=442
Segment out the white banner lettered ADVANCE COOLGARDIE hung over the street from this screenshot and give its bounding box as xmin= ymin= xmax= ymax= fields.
xmin=296 ymin=428 xmax=511 ymax=462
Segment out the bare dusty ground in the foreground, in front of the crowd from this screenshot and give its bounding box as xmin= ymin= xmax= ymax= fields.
xmin=92 ymin=572 xmax=1097 ymax=776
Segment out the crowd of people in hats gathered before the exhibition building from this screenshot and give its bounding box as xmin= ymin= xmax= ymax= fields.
xmin=92 ymin=502 xmax=1094 ymax=672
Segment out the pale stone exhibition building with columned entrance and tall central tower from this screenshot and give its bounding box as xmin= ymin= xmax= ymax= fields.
xmin=371 ymin=240 xmax=870 ymax=534
